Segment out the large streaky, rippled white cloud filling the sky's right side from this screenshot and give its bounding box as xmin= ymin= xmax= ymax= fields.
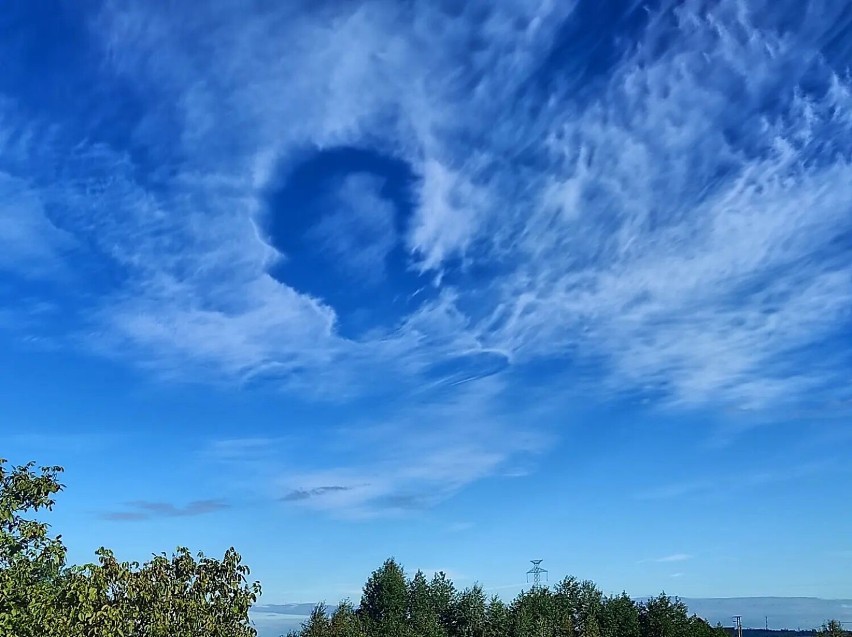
xmin=472 ymin=4 xmax=852 ymax=406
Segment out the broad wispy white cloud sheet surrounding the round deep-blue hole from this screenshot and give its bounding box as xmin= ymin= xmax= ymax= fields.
xmin=66 ymin=2 xmax=852 ymax=406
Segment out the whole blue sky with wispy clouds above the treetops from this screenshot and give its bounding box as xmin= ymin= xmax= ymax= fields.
xmin=0 ymin=0 xmax=852 ymax=620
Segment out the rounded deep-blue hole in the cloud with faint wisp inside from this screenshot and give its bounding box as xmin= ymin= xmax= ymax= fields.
xmin=265 ymin=147 xmax=434 ymax=339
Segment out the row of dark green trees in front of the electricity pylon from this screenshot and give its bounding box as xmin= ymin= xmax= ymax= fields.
xmin=288 ymin=559 xmax=728 ymax=637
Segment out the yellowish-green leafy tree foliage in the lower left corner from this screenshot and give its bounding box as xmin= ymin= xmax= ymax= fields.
xmin=0 ymin=460 xmax=260 ymax=637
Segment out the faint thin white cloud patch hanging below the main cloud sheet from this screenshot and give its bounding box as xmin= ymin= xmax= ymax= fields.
xmin=208 ymin=378 xmax=552 ymax=518
